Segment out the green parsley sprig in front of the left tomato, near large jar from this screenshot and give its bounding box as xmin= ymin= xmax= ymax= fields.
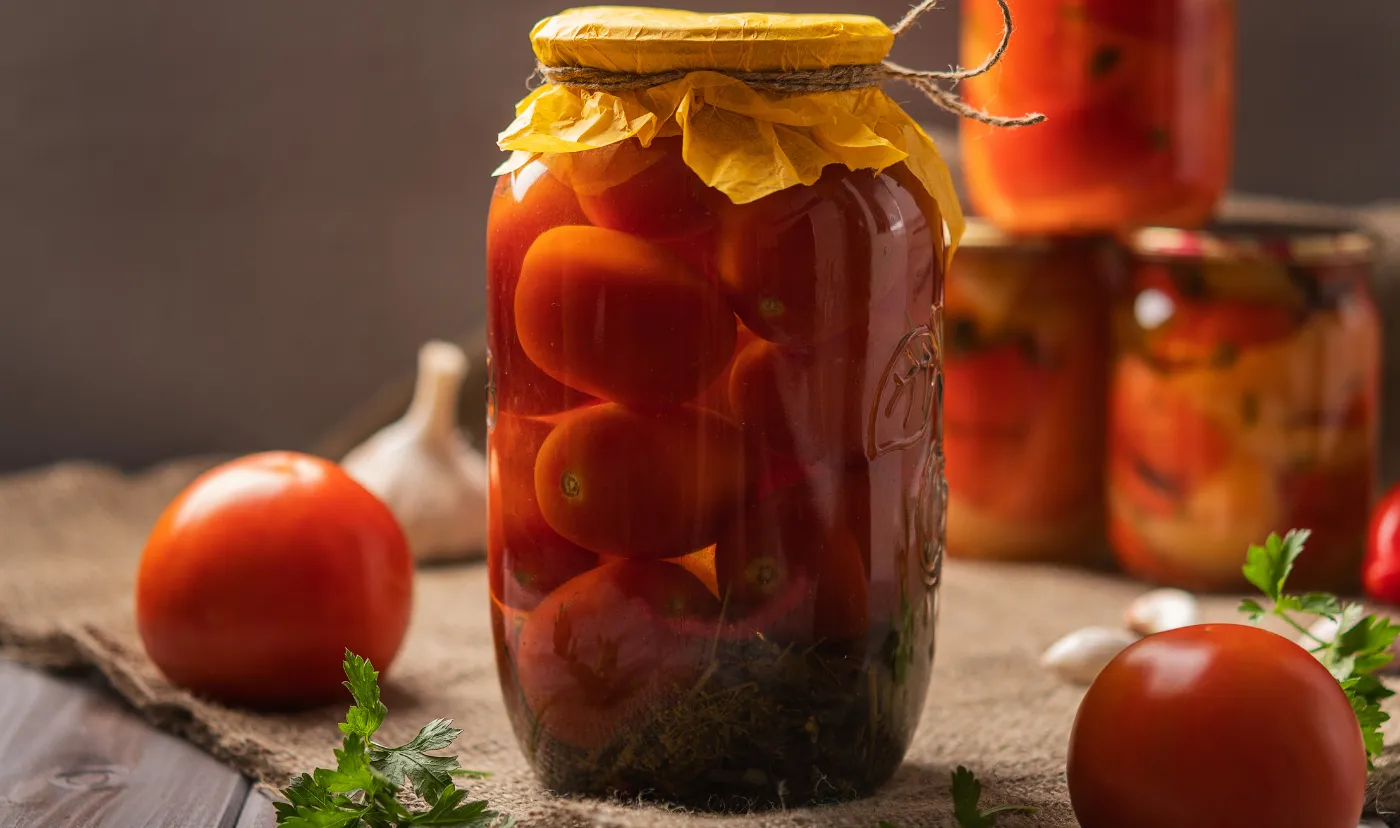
xmin=276 ymin=650 xmax=512 ymax=828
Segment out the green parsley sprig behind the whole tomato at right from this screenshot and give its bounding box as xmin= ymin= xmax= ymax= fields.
xmin=1239 ymin=530 xmax=1400 ymax=768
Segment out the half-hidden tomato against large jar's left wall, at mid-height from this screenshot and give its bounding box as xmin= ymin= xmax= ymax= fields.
xmin=486 ymin=415 xmax=598 ymax=609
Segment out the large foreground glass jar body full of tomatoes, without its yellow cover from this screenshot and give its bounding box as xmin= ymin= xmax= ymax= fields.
xmin=487 ymin=139 xmax=945 ymax=807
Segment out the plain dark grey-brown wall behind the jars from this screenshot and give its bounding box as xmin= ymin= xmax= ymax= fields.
xmin=0 ymin=0 xmax=1400 ymax=468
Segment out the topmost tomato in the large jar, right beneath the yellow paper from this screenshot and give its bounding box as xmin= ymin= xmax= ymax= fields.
xmin=568 ymin=137 xmax=725 ymax=238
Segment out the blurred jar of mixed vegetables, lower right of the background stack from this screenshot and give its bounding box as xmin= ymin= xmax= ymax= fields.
xmin=1109 ymin=224 xmax=1380 ymax=591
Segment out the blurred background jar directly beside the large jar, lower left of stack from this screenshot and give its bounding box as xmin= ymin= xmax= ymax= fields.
xmin=944 ymin=220 xmax=1116 ymax=563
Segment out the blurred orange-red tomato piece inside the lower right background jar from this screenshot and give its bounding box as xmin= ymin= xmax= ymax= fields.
xmin=1109 ymin=356 xmax=1232 ymax=492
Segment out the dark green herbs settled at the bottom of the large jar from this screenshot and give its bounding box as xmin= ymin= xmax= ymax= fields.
xmin=507 ymin=609 xmax=932 ymax=811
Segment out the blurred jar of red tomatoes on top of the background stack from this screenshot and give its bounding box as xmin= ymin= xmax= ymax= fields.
xmin=962 ymin=0 xmax=1235 ymax=233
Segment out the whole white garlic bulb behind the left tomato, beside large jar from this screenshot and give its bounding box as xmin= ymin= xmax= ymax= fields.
xmin=340 ymin=340 xmax=489 ymax=562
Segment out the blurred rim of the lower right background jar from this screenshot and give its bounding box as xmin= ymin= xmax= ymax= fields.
xmin=1128 ymin=219 xmax=1378 ymax=265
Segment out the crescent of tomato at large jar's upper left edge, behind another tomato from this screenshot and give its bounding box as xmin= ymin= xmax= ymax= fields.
xmin=486 ymin=161 xmax=588 ymax=415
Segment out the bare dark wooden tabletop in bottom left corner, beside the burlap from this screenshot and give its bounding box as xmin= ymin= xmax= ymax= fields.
xmin=0 ymin=661 xmax=248 ymax=828
